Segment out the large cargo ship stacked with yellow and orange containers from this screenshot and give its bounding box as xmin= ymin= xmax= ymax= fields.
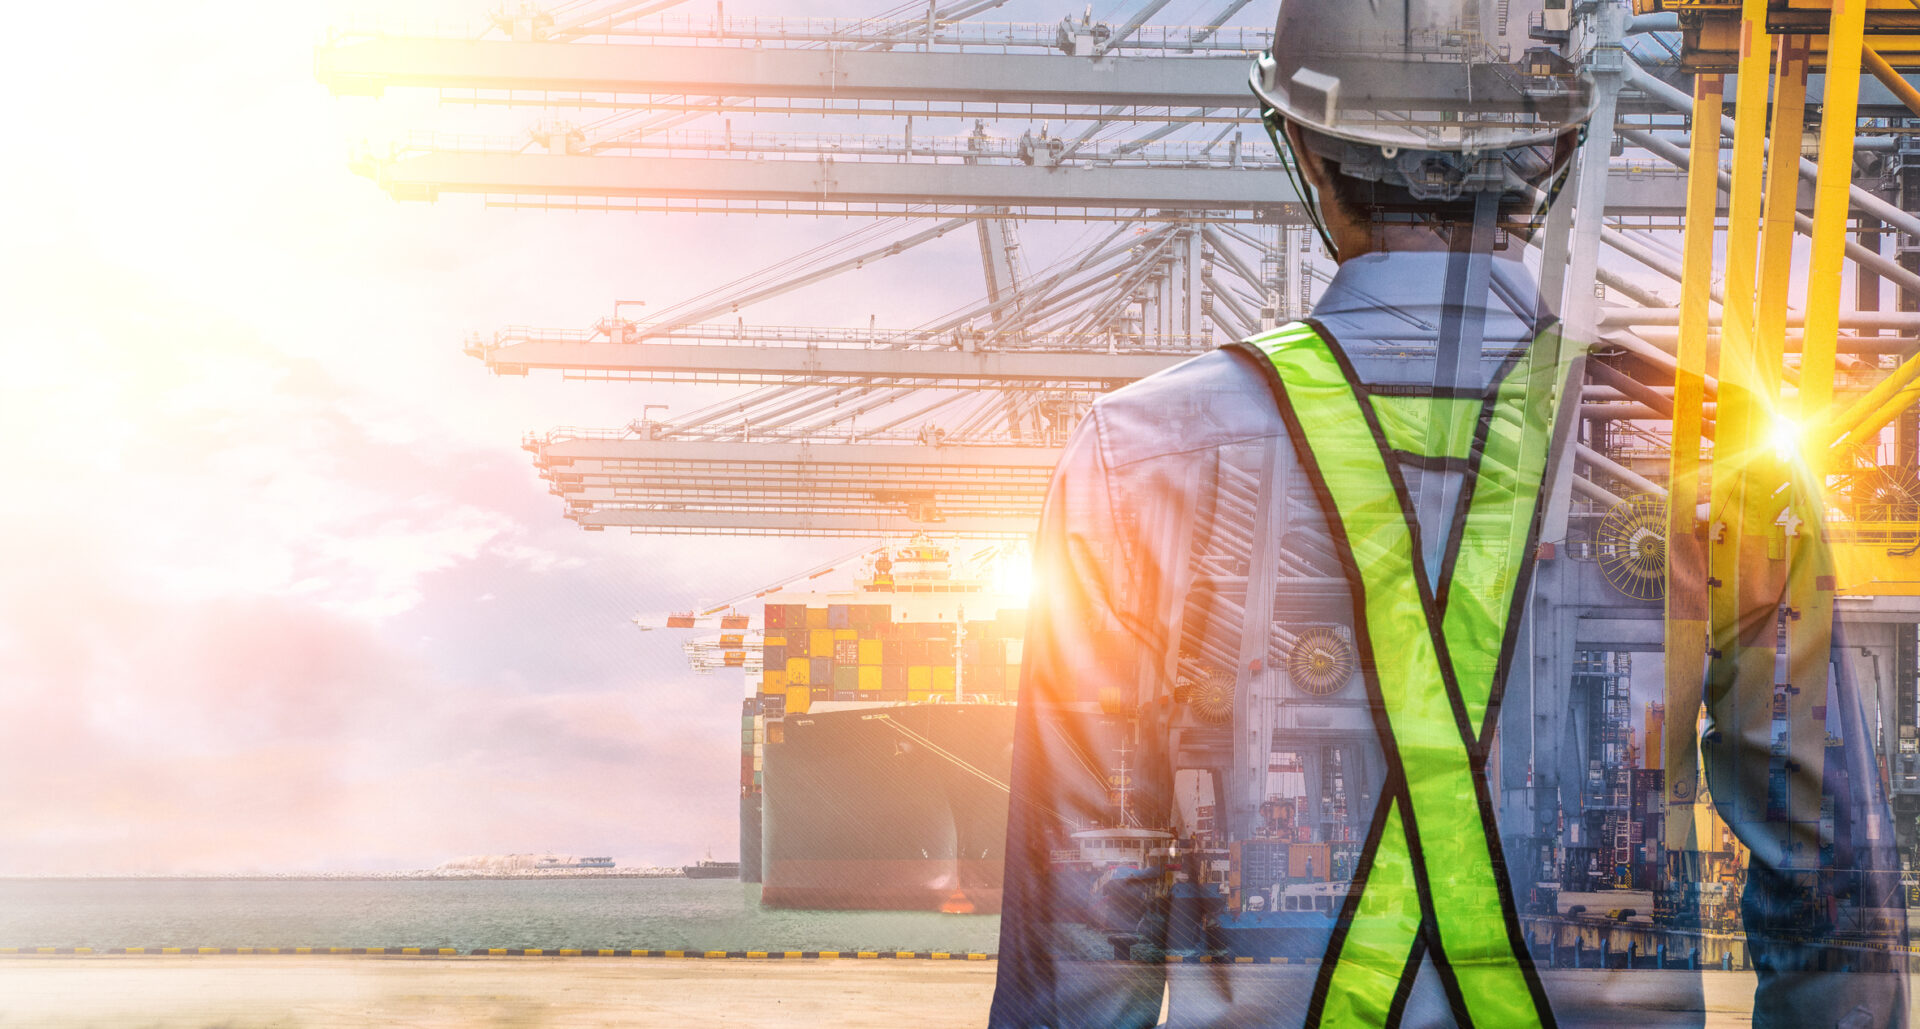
xmin=741 ymin=538 xmax=1025 ymax=914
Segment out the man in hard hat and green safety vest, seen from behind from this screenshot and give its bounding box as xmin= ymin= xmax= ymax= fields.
xmin=991 ymin=0 xmax=1905 ymax=1029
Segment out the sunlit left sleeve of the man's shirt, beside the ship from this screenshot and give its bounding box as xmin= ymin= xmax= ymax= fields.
xmin=989 ymin=407 xmax=1165 ymax=1029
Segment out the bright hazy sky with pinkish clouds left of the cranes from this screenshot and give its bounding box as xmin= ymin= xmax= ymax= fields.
xmin=0 ymin=2 xmax=1021 ymax=875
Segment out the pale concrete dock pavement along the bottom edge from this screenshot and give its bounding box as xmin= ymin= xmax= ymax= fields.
xmin=0 ymin=954 xmax=1873 ymax=1029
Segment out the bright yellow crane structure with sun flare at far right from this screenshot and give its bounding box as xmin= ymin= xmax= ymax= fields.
xmin=1634 ymin=0 xmax=1920 ymax=906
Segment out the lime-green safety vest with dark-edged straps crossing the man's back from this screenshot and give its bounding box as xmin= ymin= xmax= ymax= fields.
xmin=1240 ymin=323 xmax=1565 ymax=1029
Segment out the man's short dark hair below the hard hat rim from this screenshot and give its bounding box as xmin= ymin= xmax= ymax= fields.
xmin=1292 ymin=123 xmax=1576 ymax=236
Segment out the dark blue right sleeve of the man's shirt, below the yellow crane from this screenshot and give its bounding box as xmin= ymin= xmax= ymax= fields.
xmin=1701 ymin=552 xmax=1914 ymax=1027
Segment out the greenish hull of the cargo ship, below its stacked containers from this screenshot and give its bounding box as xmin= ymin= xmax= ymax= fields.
xmin=760 ymin=705 xmax=1014 ymax=914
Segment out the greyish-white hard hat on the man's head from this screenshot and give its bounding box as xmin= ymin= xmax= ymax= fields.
xmin=1250 ymin=0 xmax=1594 ymax=154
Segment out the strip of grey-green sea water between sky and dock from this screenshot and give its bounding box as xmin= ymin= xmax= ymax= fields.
xmin=0 ymin=877 xmax=1000 ymax=952
